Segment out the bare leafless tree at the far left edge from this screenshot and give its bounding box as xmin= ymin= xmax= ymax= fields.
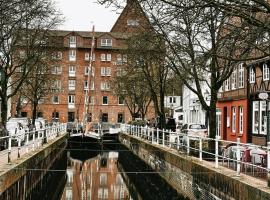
xmin=0 ymin=0 xmax=61 ymax=125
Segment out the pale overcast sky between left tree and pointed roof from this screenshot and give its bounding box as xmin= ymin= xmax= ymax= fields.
xmin=55 ymin=0 xmax=119 ymax=32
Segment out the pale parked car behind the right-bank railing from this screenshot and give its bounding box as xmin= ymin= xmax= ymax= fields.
xmin=180 ymin=123 xmax=208 ymax=137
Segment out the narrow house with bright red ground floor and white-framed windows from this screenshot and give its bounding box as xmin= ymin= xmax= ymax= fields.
xmin=217 ymin=64 xmax=250 ymax=143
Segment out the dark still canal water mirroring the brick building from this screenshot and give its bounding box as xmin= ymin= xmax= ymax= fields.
xmin=46 ymin=138 xmax=188 ymax=200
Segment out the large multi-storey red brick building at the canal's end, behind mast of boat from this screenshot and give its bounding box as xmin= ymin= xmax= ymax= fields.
xmin=12 ymin=1 xmax=153 ymax=123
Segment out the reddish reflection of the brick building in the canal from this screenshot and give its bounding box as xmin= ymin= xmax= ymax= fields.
xmin=62 ymin=152 xmax=129 ymax=200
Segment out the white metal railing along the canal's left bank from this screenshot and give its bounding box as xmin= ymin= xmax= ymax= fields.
xmin=0 ymin=124 xmax=67 ymax=163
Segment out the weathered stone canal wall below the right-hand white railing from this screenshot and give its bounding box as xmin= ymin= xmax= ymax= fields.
xmin=119 ymin=134 xmax=270 ymax=200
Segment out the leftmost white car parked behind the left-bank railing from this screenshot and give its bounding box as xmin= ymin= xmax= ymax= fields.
xmin=6 ymin=121 xmax=25 ymax=141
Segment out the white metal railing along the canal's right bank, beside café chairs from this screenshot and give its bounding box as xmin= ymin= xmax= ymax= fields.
xmin=121 ymin=124 xmax=270 ymax=185
